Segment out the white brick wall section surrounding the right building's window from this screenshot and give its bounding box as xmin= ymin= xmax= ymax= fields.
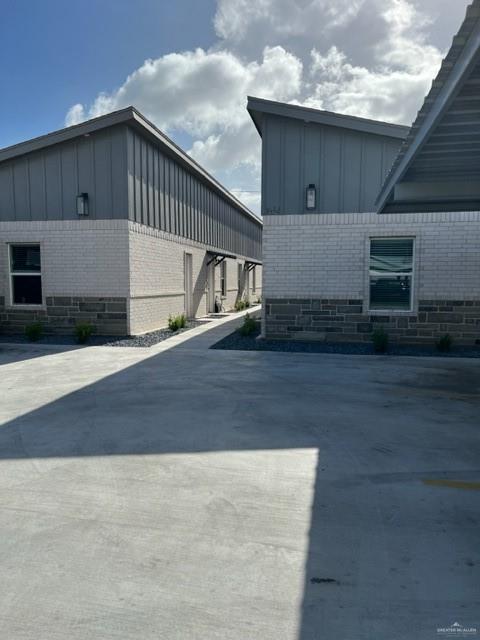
xmin=263 ymin=212 xmax=480 ymax=301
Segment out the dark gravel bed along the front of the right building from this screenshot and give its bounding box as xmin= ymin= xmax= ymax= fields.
xmin=210 ymin=330 xmax=480 ymax=358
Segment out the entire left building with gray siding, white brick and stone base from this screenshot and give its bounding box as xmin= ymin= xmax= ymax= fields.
xmin=0 ymin=107 xmax=262 ymax=334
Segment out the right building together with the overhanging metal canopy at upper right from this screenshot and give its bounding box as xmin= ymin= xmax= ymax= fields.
xmin=248 ymin=0 xmax=480 ymax=344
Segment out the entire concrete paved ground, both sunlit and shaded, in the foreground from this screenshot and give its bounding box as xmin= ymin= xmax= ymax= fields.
xmin=0 ymin=316 xmax=480 ymax=640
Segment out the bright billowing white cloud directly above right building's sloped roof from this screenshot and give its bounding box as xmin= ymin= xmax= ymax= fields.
xmin=304 ymin=0 xmax=441 ymax=124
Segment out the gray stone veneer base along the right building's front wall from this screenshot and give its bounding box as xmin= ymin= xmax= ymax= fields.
xmin=264 ymin=298 xmax=480 ymax=345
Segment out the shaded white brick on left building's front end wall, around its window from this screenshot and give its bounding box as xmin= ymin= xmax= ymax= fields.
xmin=0 ymin=220 xmax=128 ymax=304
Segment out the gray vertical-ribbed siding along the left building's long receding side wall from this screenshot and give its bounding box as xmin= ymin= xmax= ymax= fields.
xmin=126 ymin=127 xmax=262 ymax=260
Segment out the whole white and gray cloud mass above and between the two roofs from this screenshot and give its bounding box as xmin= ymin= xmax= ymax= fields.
xmin=66 ymin=0 xmax=454 ymax=206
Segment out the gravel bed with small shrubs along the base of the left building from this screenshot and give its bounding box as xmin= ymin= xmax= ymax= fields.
xmin=0 ymin=320 xmax=210 ymax=347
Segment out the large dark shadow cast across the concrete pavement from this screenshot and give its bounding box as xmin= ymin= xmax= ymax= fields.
xmin=0 ymin=338 xmax=479 ymax=640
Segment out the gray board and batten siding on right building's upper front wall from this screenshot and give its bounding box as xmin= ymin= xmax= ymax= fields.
xmin=262 ymin=115 xmax=401 ymax=215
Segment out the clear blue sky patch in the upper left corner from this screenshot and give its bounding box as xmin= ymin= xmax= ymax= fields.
xmin=0 ymin=0 xmax=215 ymax=148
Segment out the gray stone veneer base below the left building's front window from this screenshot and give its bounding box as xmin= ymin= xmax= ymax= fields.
xmin=0 ymin=296 xmax=127 ymax=335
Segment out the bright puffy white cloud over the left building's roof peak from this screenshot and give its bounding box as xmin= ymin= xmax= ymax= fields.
xmin=67 ymin=47 xmax=302 ymax=137
